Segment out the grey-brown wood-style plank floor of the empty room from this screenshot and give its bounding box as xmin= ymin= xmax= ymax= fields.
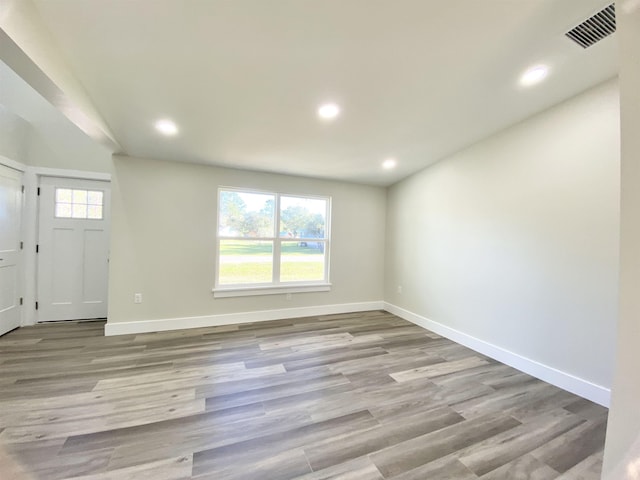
xmin=0 ymin=311 xmax=607 ymax=480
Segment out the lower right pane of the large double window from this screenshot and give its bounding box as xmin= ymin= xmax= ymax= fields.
xmin=280 ymin=241 xmax=325 ymax=282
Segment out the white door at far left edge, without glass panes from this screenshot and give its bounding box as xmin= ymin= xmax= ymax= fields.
xmin=0 ymin=165 xmax=22 ymax=335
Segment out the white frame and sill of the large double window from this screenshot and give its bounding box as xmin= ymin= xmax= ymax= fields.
xmin=212 ymin=187 xmax=331 ymax=298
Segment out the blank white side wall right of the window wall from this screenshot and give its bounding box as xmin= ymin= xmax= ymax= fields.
xmin=385 ymin=80 xmax=619 ymax=403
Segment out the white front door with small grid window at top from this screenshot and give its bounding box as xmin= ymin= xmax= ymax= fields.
xmin=37 ymin=177 xmax=111 ymax=322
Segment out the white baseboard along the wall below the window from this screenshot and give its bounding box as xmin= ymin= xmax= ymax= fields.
xmin=104 ymin=301 xmax=384 ymax=336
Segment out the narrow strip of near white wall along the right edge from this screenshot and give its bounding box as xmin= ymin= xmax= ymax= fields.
xmin=602 ymin=1 xmax=640 ymax=480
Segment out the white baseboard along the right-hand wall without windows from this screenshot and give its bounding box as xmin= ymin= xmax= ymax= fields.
xmin=384 ymin=302 xmax=611 ymax=407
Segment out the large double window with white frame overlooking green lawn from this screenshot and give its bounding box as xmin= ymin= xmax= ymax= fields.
xmin=214 ymin=188 xmax=331 ymax=296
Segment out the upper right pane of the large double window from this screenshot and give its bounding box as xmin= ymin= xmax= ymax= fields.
xmin=280 ymin=196 xmax=327 ymax=238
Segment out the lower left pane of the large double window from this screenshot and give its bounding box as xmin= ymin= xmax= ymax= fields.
xmin=219 ymin=240 xmax=273 ymax=285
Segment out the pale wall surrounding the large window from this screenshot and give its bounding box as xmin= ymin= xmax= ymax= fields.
xmin=107 ymin=156 xmax=386 ymax=333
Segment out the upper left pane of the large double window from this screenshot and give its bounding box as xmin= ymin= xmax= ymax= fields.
xmin=218 ymin=190 xmax=275 ymax=238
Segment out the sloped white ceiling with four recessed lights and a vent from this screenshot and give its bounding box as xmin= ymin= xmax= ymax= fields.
xmin=11 ymin=0 xmax=617 ymax=185
